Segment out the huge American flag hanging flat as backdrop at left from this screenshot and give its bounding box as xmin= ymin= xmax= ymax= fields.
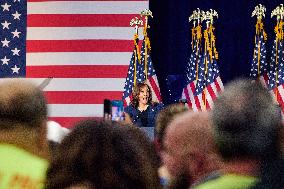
xmin=0 ymin=0 xmax=148 ymax=127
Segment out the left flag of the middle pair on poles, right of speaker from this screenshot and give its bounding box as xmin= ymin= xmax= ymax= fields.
xmin=182 ymin=26 xmax=202 ymax=111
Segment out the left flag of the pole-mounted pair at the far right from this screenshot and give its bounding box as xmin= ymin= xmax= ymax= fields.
xmin=250 ymin=20 xmax=269 ymax=86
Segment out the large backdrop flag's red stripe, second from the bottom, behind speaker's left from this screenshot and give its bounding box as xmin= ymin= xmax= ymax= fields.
xmin=44 ymin=91 xmax=122 ymax=104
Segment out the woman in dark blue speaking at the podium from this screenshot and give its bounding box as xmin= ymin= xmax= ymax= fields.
xmin=124 ymin=83 xmax=163 ymax=140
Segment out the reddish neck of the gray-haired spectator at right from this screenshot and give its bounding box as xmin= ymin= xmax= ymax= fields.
xmin=222 ymin=159 xmax=260 ymax=176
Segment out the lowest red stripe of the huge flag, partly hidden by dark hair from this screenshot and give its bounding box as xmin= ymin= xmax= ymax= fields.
xmin=48 ymin=117 xmax=103 ymax=129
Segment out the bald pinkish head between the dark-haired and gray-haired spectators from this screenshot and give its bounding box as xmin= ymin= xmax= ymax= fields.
xmin=163 ymin=112 xmax=220 ymax=182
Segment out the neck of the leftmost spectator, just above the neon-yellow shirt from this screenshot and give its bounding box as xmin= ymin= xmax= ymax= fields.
xmin=0 ymin=127 xmax=48 ymax=159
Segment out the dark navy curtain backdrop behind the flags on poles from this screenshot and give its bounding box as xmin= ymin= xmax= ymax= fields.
xmin=149 ymin=0 xmax=283 ymax=104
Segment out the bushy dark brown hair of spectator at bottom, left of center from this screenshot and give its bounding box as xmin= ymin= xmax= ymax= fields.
xmin=46 ymin=120 xmax=160 ymax=189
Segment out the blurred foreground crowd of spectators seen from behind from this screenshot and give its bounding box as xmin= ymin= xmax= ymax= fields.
xmin=0 ymin=79 xmax=284 ymax=189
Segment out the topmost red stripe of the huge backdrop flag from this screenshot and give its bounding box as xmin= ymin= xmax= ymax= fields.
xmin=27 ymin=14 xmax=139 ymax=27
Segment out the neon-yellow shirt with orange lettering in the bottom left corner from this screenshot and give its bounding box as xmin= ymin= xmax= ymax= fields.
xmin=0 ymin=144 xmax=48 ymax=189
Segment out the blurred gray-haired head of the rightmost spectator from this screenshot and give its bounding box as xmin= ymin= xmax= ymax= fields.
xmin=212 ymin=79 xmax=281 ymax=160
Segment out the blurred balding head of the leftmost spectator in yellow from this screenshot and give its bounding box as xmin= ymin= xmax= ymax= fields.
xmin=0 ymin=79 xmax=47 ymax=130
